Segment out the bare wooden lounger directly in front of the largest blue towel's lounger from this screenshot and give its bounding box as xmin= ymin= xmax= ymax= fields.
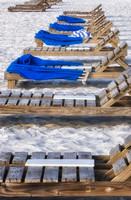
xmin=0 ymin=67 xmax=131 ymax=116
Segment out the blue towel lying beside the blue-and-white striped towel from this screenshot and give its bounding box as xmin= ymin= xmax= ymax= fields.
xmin=35 ymin=30 xmax=82 ymax=46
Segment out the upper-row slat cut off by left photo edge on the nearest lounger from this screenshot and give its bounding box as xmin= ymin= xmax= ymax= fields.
xmin=0 ymin=152 xmax=12 ymax=164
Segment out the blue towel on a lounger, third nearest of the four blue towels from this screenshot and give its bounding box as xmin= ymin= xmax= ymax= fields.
xmin=50 ymin=22 xmax=84 ymax=31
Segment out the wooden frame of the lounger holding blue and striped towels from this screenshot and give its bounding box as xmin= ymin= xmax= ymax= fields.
xmin=35 ymin=22 xmax=119 ymax=48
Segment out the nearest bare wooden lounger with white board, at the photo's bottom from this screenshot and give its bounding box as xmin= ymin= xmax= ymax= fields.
xmin=0 ymin=135 xmax=131 ymax=197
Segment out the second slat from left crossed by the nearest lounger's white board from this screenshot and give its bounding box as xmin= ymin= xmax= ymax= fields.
xmin=43 ymin=152 xmax=61 ymax=183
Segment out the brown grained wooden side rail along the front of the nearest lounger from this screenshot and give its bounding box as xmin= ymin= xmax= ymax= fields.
xmin=0 ymin=181 xmax=131 ymax=197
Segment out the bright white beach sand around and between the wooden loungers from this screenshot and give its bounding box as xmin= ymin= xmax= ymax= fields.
xmin=0 ymin=0 xmax=131 ymax=154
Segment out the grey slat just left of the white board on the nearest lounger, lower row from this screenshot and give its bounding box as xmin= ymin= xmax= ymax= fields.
xmin=6 ymin=166 xmax=24 ymax=183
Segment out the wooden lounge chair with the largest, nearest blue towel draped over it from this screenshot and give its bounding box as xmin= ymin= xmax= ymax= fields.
xmin=4 ymin=42 xmax=129 ymax=89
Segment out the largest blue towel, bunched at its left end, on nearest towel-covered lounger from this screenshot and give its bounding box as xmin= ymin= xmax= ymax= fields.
xmin=7 ymin=54 xmax=83 ymax=81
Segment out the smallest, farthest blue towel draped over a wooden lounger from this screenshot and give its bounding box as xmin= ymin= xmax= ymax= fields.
xmin=57 ymin=15 xmax=86 ymax=23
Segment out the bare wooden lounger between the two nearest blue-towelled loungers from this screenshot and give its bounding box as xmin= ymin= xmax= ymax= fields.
xmin=23 ymin=32 xmax=127 ymax=57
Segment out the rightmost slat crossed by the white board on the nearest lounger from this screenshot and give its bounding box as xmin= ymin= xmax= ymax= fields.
xmin=78 ymin=152 xmax=95 ymax=182
